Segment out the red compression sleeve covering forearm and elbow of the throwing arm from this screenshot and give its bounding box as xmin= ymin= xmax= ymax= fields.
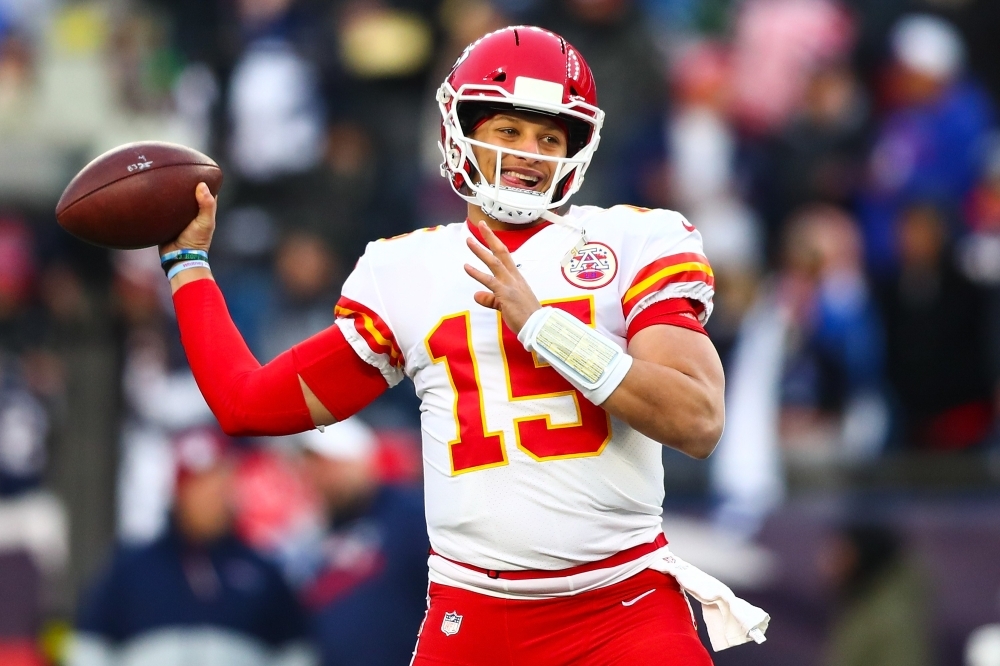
xmin=174 ymin=279 xmax=314 ymax=436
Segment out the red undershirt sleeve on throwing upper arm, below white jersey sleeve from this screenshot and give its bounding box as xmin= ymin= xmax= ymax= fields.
xmin=292 ymin=326 xmax=389 ymax=421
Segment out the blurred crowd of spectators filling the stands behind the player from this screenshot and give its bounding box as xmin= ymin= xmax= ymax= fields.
xmin=0 ymin=0 xmax=1000 ymax=666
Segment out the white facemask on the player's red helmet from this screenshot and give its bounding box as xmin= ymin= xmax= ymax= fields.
xmin=437 ymin=81 xmax=604 ymax=224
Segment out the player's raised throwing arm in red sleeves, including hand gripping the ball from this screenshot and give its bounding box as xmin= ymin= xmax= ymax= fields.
xmin=160 ymin=184 xmax=388 ymax=435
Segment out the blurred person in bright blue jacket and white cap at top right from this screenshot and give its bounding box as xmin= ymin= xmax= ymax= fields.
xmin=860 ymin=15 xmax=995 ymax=274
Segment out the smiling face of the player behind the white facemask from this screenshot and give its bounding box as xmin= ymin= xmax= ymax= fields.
xmin=471 ymin=111 xmax=566 ymax=192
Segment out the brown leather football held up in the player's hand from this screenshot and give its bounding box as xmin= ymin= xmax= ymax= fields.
xmin=56 ymin=141 xmax=222 ymax=249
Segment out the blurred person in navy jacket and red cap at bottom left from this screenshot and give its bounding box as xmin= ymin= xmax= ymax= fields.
xmin=67 ymin=430 xmax=312 ymax=666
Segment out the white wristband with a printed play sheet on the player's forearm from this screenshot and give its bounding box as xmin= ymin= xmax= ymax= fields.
xmin=517 ymin=307 xmax=632 ymax=405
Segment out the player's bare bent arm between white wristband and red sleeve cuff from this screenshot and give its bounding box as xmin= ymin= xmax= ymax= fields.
xmin=601 ymin=324 xmax=726 ymax=458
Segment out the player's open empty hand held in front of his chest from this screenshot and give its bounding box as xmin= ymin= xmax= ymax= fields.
xmin=465 ymin=221 xmax=542 ymax=333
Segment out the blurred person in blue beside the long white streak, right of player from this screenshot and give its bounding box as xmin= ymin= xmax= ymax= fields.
xmin=778 ymin=206 xmax=888 ymax=459
